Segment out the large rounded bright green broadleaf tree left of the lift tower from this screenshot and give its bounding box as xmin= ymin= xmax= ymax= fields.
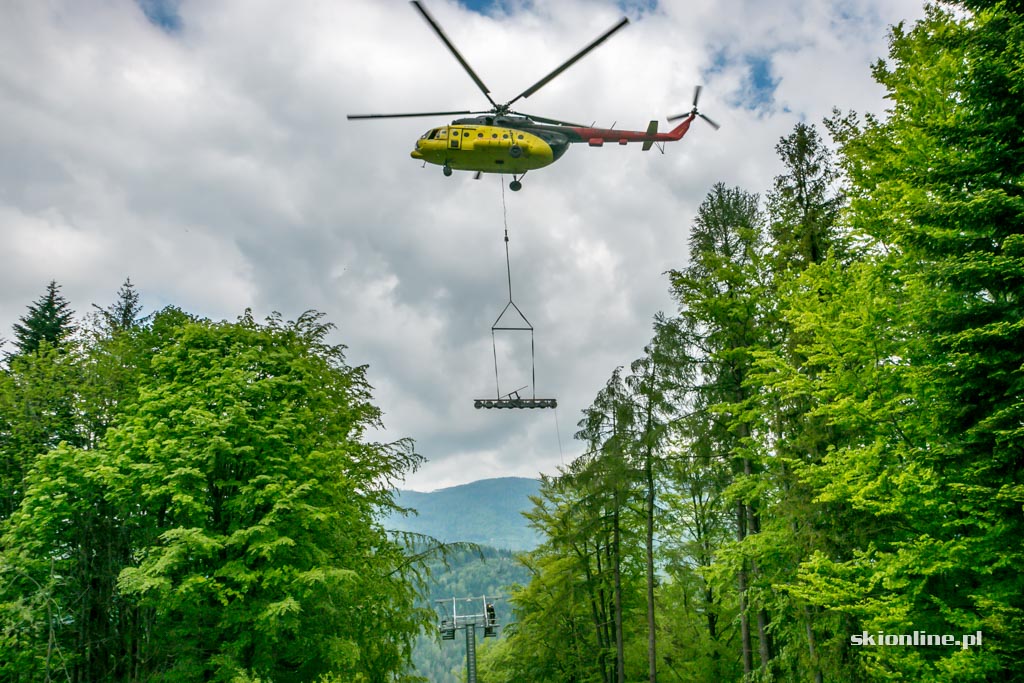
xmin=108 ymin=315 xmax=428 ymax=681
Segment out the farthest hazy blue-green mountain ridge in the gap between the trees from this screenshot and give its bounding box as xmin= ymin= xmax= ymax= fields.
xmin=385 ymin=477 xmax=541 ymax=550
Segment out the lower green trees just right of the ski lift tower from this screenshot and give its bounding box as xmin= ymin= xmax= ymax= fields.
xmin=479 ymin=475 xmax=645 ymax=683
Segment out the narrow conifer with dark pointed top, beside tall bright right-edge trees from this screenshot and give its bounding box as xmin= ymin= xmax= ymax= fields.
xmin=746 ymin=123 xmax=856 ymax=682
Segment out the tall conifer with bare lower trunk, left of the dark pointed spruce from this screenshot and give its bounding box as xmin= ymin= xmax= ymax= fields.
xmin=669 ymin=183 xmax=772 ymax=677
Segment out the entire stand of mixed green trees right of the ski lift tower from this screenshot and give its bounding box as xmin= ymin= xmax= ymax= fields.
xmin=481 ymin=2 xmax=1024 ymax=683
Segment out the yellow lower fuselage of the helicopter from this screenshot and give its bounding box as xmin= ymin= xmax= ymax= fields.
xmin=412 ymin=124 xmax=555 ymax=174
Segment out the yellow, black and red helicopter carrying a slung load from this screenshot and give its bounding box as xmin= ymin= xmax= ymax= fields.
xmin=348 ymin=0 xmax=719 ymax=191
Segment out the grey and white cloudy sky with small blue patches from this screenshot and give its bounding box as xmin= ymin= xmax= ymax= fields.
xmin=0 ymin=0 xmax=923 ymax=490
